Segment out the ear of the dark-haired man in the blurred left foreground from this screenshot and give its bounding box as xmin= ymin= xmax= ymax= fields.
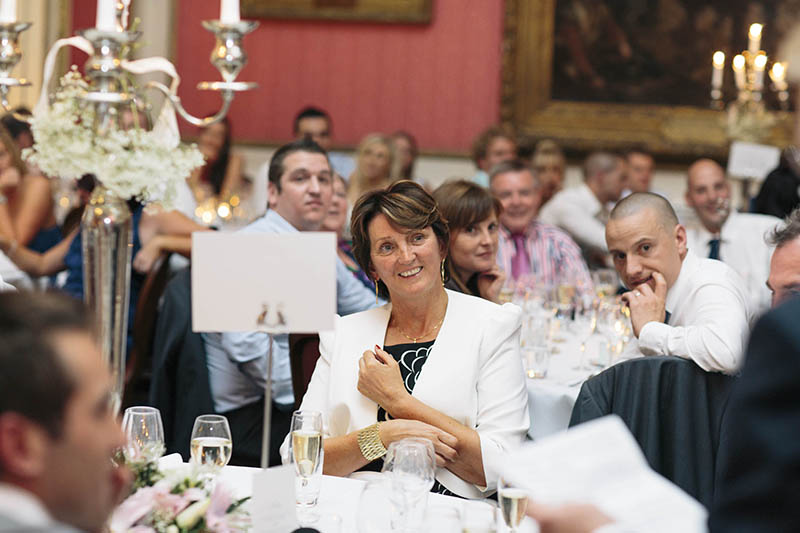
xmin=0 ymin=412 xmax=50 ymax=479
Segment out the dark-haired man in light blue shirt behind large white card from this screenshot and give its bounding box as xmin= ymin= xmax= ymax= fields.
xmin=203 ymin=138 xmax=376 ymax=466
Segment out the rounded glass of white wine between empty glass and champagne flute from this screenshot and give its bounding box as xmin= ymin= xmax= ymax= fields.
xmin=190 ymin=415 xmax=233 ymax=480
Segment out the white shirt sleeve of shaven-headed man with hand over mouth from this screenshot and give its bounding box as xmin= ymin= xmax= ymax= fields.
xmin=639 ymin=283 xmax=749 ymax=373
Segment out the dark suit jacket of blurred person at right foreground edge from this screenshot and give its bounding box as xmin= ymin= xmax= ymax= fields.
xmin=709 ymin=299 xmax=800 ymax=533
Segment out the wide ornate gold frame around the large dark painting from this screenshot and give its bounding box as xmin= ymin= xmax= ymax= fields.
xmin=500 ymin=0 xmax=793 ymax=160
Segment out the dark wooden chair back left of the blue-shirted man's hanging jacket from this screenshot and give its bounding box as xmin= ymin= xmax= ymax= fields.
xmin=123 ymin=253 xmax=172 ymax=406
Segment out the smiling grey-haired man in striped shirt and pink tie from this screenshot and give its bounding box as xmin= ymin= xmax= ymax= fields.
xmin=490 ymin=160 xmax=593 ymax=294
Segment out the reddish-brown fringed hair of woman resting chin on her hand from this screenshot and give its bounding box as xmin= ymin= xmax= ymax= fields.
xmin=433 ymin=180 xmax=503 ymax=234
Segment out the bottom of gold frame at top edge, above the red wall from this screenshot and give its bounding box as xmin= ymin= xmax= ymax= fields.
xmin=241 ymin=0 xmax=433 ymax=24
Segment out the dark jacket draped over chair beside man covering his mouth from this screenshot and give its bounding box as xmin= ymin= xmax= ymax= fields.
xmin=569 ymin=356 xmax=734 ymax=506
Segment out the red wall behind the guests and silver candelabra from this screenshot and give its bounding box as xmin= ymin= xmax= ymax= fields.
xmin=73 ymin=0 xmax=504 ymax=152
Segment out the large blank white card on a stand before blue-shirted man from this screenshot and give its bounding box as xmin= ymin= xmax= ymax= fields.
xmin=192 ymin=231 xmax=336 ymax=333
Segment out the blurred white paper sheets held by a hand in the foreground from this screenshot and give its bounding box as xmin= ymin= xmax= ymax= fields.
xmin=502 ymin=415 xmax=707 ymax=533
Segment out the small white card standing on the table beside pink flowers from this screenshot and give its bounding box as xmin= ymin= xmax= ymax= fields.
xmin=250 ymin=465 xmax=298 ymax=533
